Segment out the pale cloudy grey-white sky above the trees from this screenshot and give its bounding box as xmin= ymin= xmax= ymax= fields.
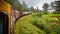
xmin=18 ymin=0 xmax=57 ymax=10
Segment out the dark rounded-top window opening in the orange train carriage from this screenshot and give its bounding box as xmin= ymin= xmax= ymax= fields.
xmin=0 ymin=11 xmax=8 ymax=34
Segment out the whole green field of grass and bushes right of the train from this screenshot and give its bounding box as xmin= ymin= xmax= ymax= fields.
xmin=14 ymin=13 xmax=60 ymax=34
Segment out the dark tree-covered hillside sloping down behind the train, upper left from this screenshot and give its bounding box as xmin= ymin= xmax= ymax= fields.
xmin=6 ymin=0 xmax=27 ymax=11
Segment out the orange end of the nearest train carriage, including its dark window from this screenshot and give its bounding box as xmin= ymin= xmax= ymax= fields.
xmin=0 ymin=0 xmax=10 ymax=34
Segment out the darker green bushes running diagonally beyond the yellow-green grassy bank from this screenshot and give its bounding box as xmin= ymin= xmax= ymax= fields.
xmin=31 ymin=13 xmax=56 ymax=34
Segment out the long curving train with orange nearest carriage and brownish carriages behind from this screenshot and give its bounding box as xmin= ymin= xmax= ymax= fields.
xmin=0 ymin=0 xmax=32 ymax=34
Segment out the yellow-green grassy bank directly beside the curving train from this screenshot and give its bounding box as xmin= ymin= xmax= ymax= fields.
xmin=14 ymin=15 xmax=46 ymax=34
